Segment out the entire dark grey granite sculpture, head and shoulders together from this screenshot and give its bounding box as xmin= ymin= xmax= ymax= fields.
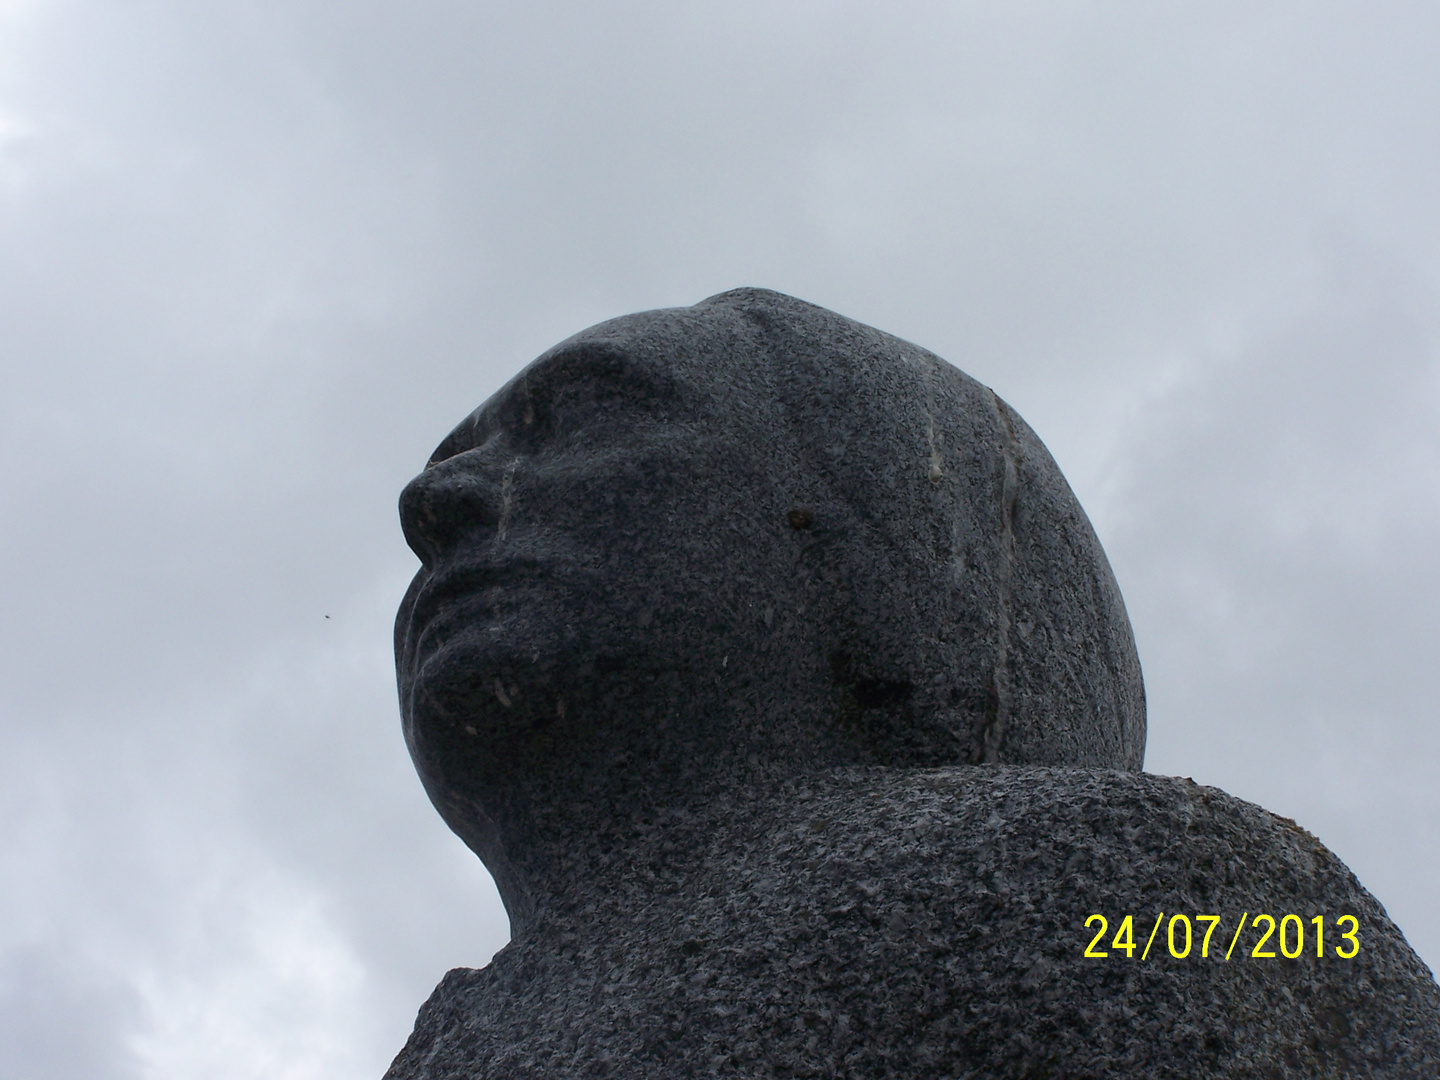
xmin=387 ymin=289 xmax=1440 ymax=1080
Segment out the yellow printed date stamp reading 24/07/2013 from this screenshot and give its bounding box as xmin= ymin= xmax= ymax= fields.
xmin=1084 ymin=912 xmax=1359 ymax=960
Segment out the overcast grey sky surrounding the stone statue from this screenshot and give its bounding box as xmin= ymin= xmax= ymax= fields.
xmin=0 ymin=0 xmax=1440 ymax=1080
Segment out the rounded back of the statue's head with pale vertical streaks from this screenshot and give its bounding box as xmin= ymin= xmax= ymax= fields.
xmin=696 ymin=289 xmax=1145 ymax=769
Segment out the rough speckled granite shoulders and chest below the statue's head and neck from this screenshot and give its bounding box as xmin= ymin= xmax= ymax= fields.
xmin=390 ymin=766 xmax=1440 ymax=1080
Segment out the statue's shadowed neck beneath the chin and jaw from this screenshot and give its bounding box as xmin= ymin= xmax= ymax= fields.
xmin=418 ymin=696 xmax=854 ymax=939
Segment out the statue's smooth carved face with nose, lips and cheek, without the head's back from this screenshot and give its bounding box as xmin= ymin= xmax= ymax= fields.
xmin=396 ymin=308 xmax=816 ymax=817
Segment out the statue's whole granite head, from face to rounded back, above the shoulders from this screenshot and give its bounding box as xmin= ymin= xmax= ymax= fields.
xmin=396 ymin=289 xmax=1145 ymax=904
